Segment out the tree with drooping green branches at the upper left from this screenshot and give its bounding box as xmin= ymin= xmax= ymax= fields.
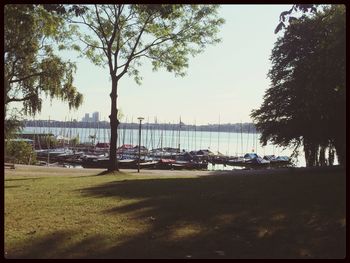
xmin=4 ymin=4 xmax=83 ymax=121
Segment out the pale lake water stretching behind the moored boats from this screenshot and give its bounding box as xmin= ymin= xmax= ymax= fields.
xmin=25 ymin=125 xmax=305 ymax=169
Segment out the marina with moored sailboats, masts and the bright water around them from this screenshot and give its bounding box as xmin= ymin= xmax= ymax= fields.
xmin=20 ymin=123 xmax=296 ymax=170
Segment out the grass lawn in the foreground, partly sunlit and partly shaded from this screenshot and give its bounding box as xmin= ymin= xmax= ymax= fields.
xmin=4 ymin=166 xmax=346 ymax=258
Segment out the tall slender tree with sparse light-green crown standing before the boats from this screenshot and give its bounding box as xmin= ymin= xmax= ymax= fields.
xmin=70 ymin=5 xmax=224 ymax=171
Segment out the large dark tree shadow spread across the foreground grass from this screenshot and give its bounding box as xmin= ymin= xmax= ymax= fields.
xmin=7 ymin=170 xmax=346 ymax=258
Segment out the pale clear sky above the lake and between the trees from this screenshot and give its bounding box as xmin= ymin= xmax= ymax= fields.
xmin=28 ymin=5 xmax=291 ymax=125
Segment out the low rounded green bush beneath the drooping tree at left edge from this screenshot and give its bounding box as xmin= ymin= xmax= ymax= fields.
xmin=5 ymin=140 xmax=36 ymax=164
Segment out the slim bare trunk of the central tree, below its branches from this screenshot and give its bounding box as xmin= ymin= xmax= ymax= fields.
xmin=108 ymin=76 xmax=119 ymax=172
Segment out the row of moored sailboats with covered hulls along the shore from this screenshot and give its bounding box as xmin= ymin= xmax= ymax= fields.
xmin=36 ymin=145 xmax=292 ymax=170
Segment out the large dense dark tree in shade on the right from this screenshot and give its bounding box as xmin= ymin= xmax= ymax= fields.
xmin=251 ymin=5 xmax=346 ymax=166
